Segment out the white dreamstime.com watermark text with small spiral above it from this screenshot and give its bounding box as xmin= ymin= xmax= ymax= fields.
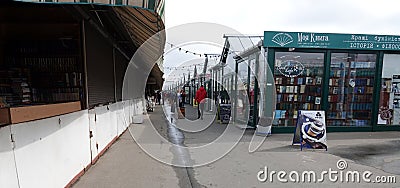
xmin=257 ymin=159 xmax=396 ymax=183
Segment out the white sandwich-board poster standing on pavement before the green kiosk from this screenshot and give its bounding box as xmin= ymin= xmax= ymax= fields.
xmin=293 ymin=110 xmax=328 ymax=150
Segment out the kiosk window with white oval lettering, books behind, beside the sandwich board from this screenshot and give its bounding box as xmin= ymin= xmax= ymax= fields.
xmin=273 ymin=52 xmax=324 ymax=126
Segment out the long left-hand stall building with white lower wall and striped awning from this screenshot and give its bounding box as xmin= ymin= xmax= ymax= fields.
xmin=0 ymin=0 xmax=165 ymax=187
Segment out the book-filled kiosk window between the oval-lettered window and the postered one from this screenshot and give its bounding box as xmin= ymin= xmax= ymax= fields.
xmin=327 ymin=53 xmax=376 ymax=126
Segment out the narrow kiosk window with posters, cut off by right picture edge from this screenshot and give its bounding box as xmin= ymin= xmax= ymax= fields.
xmin=377 ymin=54 xmax=400 ymax=125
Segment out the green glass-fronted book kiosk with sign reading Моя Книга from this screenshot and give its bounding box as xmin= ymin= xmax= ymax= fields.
xmin=232 ymin=31 xmax=400 ymax=133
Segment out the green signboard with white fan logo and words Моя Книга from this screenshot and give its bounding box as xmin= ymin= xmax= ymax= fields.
xmin=264 ymin=31 xmax=400 ymax=50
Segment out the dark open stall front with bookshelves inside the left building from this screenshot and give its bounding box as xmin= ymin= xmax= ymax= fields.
xmin=0 ymin=39 xmax=83 ymax=107
